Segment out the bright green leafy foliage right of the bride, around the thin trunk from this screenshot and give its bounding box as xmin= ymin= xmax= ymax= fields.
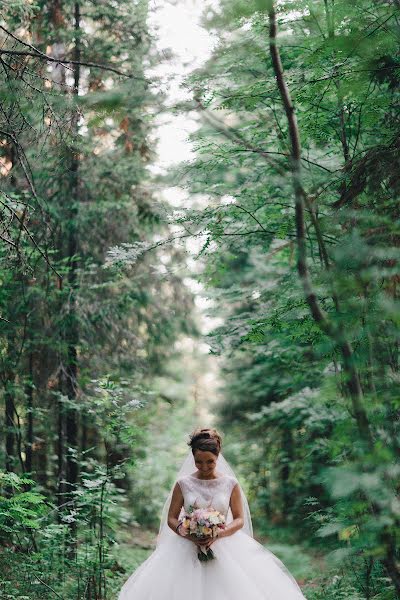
xmin=170 ymin=0 xmax=400 ymax=599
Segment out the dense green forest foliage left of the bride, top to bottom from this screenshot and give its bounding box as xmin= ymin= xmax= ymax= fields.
xmin=0 ymin=0 xmax=195 ymax=600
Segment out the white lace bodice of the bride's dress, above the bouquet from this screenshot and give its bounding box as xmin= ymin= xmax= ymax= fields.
xmin=178 ymin=475 xmax=238 ymax=517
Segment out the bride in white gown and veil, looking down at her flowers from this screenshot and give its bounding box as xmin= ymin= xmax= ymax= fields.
xmin=118 ymin=429 xmax=305 ymax=600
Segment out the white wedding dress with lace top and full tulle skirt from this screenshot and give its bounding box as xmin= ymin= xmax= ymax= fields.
xmin=118 ymin=474 xmax=304 ymax=600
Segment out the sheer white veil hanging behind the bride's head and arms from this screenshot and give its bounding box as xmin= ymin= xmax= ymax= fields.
xmin=157 ymin=450 xmax=253 ymax=548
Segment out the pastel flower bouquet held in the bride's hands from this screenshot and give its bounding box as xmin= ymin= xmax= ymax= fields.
xmin=179 ymin=506 xmax=225 ymax=562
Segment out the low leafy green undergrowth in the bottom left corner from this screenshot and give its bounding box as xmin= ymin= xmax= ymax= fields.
xmin=0 ymin=461 xmax=127 ymax=600
